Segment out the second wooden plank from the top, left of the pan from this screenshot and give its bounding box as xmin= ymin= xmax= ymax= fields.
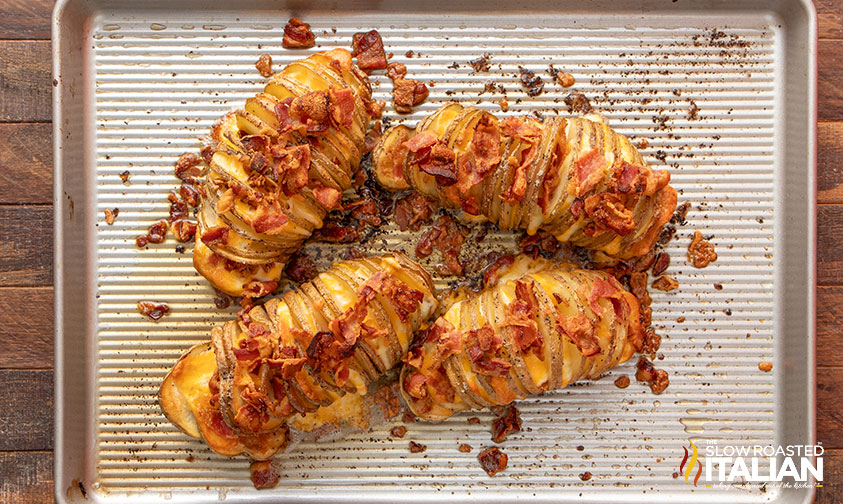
xmin=0 ymin=40 xmax=53 ymax=122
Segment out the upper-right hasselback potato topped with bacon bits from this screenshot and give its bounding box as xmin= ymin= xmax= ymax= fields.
xmin=373 ymin=103 xmax=676 ymax=259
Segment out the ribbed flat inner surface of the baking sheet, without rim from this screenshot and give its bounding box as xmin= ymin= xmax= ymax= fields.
xmin=91 ymin=8 xmax=782 ymax=502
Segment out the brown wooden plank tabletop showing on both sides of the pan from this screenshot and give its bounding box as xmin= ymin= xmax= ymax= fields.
xmin=0 ymin=0 xmax=843 ymax=504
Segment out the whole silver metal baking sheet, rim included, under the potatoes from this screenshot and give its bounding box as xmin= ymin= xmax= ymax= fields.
xmin=54 ymin=0 xmax=816 ymax=503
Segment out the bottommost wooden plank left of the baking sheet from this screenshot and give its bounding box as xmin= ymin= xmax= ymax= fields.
xmin=0 ymin=452 xmax=54 ymax=504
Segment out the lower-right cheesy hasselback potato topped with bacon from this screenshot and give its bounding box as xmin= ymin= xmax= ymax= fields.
xmin=399 ymin=255 xmax=644 ymax=420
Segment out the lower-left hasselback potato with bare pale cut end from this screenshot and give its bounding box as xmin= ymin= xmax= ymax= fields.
xmin=159 ymin=253 xmax=438 ymax=459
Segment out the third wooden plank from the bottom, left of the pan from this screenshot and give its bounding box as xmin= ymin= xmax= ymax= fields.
xmin=0 ymin=287 xmax=53 ymax=366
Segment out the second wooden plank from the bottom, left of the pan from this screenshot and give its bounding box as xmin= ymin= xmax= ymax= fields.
xmin=0 ymin=369 xmax=53 ymax=448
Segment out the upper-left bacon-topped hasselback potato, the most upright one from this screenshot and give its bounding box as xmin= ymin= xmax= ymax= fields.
xmin=193 ymin=49 xmax=371 ymax=297
